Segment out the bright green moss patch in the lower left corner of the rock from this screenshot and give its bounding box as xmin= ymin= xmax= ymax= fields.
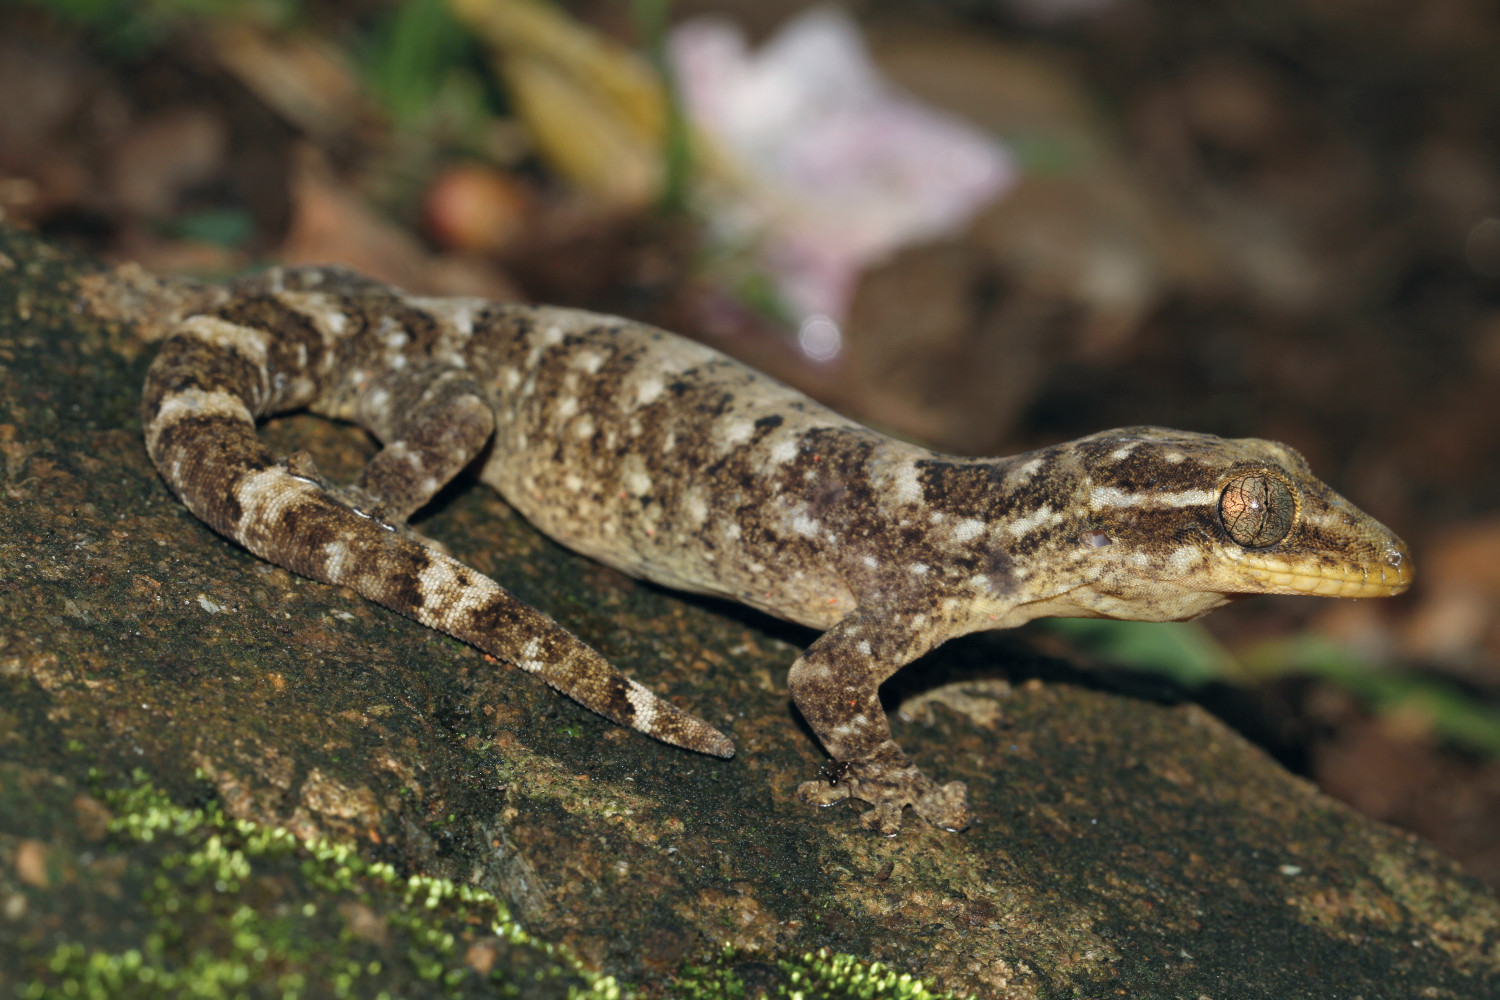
xmin=20 ymin=774 xmax=621 ymax=1000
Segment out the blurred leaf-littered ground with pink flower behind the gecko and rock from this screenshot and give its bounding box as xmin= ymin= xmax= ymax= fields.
xmin=0 ymin=0 xmax=1500 ymax=886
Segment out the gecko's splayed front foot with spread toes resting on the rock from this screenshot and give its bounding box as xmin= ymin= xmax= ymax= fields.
xmin=797 ymin=760 xmax=971 ymax=837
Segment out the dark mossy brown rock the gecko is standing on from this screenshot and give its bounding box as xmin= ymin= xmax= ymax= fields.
xmin=0 ymin=228 xmax=1500 ymax=1000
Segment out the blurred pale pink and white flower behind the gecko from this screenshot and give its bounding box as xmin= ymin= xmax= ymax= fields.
xmin=671 ymin=7 xmax=1016 ymax=352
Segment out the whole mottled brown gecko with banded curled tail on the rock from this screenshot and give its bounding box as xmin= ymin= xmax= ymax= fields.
xmin=143 ymin=267 xmax=1413 ymax=835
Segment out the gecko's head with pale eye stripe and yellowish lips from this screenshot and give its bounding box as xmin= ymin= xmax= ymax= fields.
xmin=1077 ymin=427 xmax=1413 ymax=618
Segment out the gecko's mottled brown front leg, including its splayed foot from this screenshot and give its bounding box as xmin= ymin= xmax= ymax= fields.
xmin=788 ymin=612 xmax=969 ymax=837
